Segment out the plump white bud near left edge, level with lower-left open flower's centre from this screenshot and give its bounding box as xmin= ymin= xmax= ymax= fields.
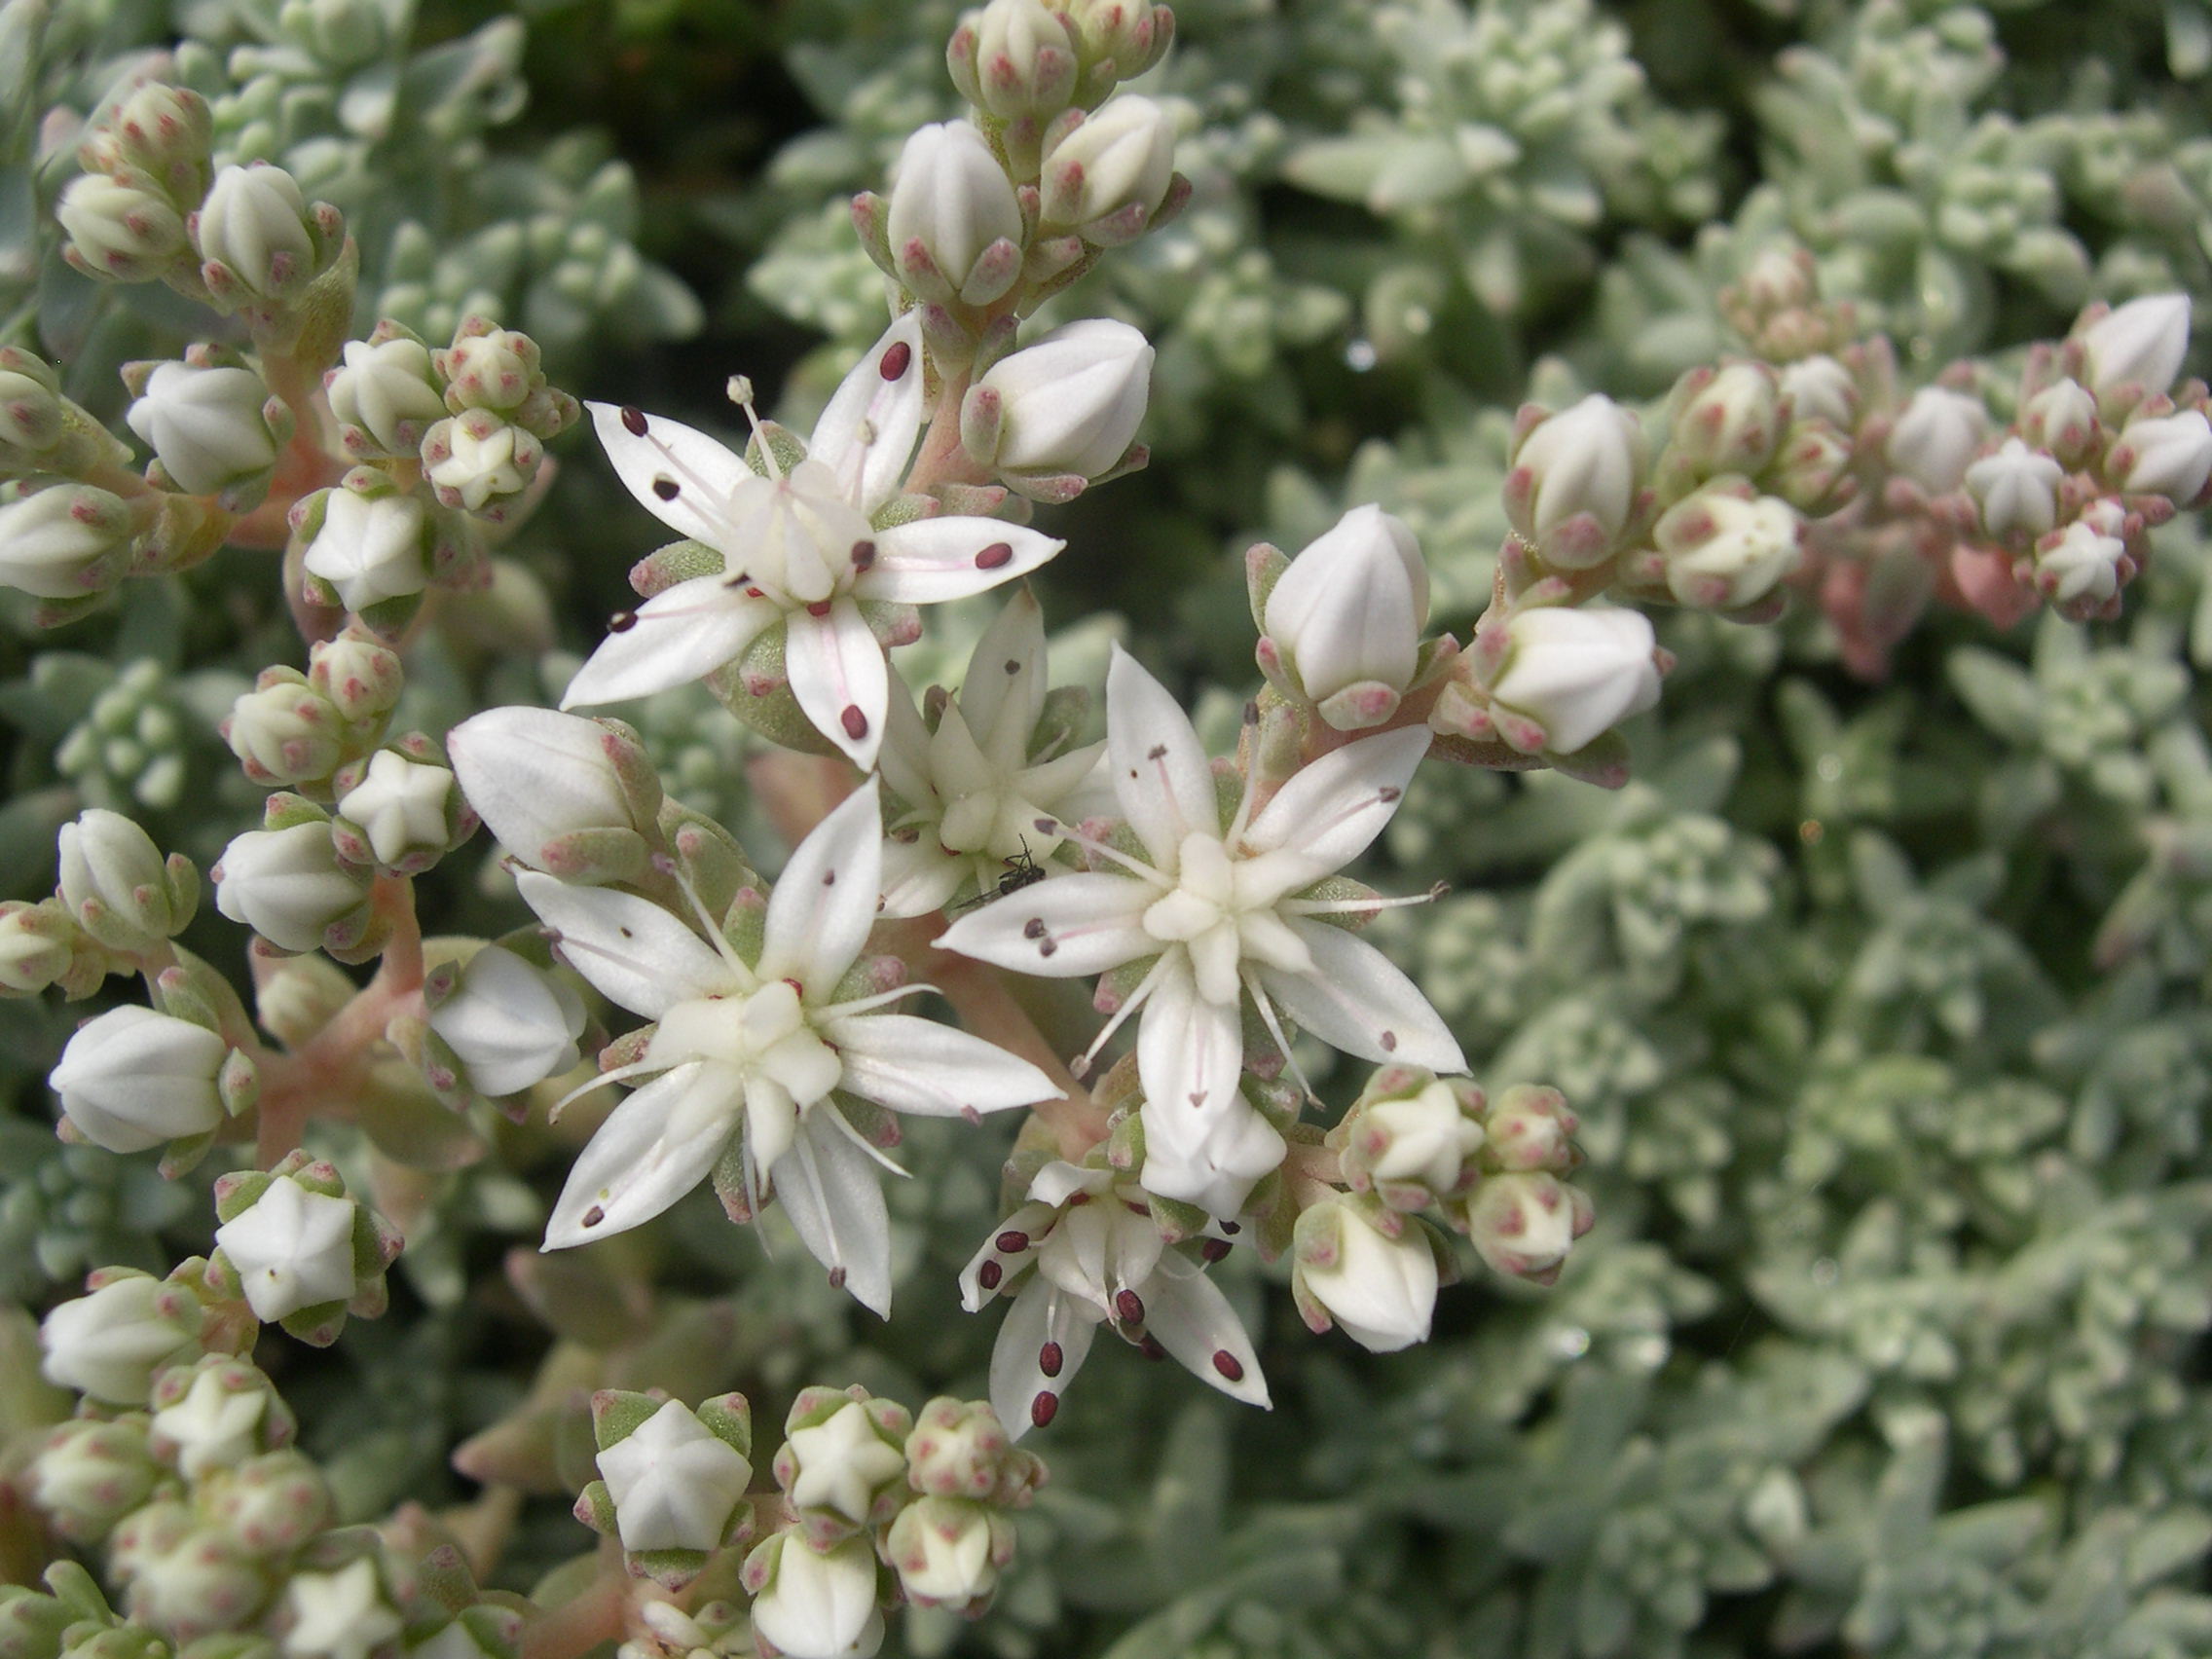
xmin=47 ymin=1009 xmax=230 ymax=1153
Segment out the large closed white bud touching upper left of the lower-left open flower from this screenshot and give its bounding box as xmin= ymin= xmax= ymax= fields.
xmin=447 ymin=708 xmax=661 ymax=880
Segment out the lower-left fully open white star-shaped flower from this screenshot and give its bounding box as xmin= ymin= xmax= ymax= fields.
xmin=506 ymin=779 xmax=1057 ymax=1314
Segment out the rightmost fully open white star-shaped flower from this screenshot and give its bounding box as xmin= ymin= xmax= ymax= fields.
xmin=938 ymin=648 xmax=1466 ymax=1219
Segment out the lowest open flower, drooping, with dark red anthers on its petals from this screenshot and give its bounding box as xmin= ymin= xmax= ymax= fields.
xmin=960 ymin=1163 xmax=1268 ymax=1440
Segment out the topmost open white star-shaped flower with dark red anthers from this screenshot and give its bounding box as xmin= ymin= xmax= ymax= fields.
xmin=562 ymin=312 xmax=1064 ymax=767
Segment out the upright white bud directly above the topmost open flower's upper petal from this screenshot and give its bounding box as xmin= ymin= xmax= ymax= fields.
xmin=887 ymin=126 xmax=1021 ymax=303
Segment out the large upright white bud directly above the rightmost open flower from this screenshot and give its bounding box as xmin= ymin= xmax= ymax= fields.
xmin=1263 ymin=504 xmax=1429 ymax=730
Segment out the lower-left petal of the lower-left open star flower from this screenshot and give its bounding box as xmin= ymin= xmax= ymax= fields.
xmin=544 ymin=1062 xmax=739 ymax=1250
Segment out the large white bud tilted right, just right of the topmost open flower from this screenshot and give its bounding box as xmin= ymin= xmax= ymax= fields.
xmin=979 ymin=318 xmax=1153 ymax=478
